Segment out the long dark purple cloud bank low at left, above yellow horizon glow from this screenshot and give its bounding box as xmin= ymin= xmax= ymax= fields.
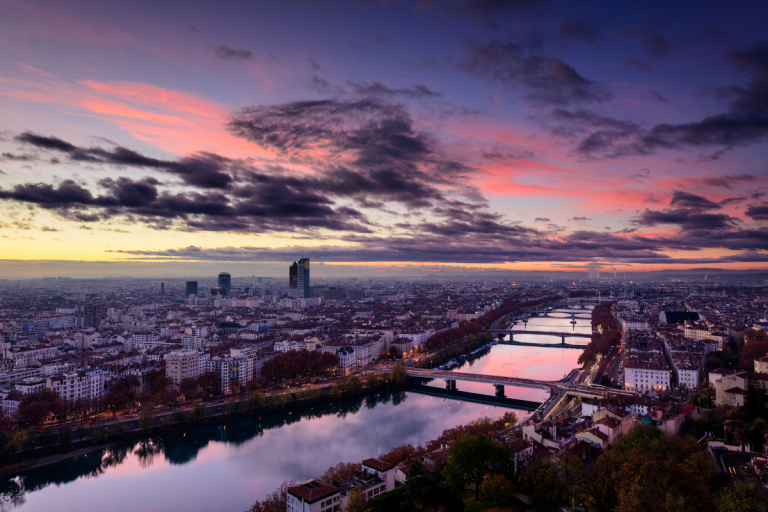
xmin=0 ymin=177 xmax=370 ymax=233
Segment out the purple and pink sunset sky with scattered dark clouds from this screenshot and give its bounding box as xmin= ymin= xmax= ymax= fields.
xmin=0 ymin=0 xmax=768 ymax=276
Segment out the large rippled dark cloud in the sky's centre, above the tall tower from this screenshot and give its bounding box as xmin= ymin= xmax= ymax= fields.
xmin=229 ymin=98 xmax=474 ymax=200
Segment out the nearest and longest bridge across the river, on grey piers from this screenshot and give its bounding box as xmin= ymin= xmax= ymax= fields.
xmin=406 ymin=368 xmax=634 ymax=398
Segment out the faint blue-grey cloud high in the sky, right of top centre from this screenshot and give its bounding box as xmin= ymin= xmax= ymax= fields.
xmin=456 ymin=38 xmax=611 ymax=105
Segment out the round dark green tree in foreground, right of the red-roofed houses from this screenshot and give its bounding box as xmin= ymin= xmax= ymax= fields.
xmin=443 ymin=434 xmax=509 ymax=500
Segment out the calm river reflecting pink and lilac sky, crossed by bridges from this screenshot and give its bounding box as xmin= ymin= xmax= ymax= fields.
xmin=0 ymin=306 xmax=590 ymax=512
